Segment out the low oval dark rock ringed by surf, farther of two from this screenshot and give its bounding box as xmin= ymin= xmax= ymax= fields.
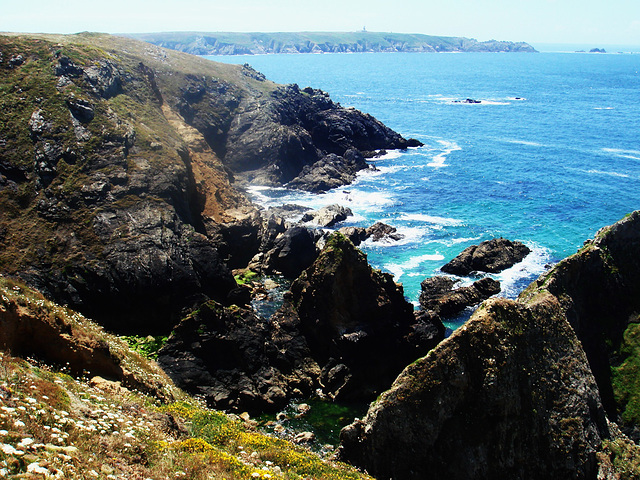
xmin=441 ymin=238 xmax=531 ymax=276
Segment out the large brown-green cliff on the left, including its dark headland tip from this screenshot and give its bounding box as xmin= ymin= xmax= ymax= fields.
xmin=0 ymin=33 xmax=414 ymax=333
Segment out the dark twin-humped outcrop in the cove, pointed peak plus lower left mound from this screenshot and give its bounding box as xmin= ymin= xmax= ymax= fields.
xmin=158 ymin=233 xmax=444 ymax=412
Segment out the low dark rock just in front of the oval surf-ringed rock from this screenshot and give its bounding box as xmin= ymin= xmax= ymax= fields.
xmin=420 ymin=276 xmax=500 ymax=318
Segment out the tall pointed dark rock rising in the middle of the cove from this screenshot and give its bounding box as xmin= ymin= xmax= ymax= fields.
xmin=291 ymin=233 xmax=439 ymax=400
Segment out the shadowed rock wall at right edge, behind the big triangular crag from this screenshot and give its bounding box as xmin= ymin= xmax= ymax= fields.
xmin=520 ymin=211 xmax=640 ymax=440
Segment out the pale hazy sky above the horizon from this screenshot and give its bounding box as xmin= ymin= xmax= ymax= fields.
xmin=0 ymin=0 xmax=640 ymax=45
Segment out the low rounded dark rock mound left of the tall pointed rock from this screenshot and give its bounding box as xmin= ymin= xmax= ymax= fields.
xmin=158 ymin=302 xmax=319 ymax=412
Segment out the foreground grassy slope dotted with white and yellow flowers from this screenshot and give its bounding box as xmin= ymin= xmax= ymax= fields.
xmin=0 ymin=278 xmax=369 ymax=480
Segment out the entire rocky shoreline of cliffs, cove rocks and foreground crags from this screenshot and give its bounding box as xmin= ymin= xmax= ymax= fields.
xmin=0 ymin=34 xmax=640 ymax=480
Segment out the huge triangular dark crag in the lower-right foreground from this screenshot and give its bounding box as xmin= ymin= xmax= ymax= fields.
xmin=340 ymin=296 xmax=608 ymax=480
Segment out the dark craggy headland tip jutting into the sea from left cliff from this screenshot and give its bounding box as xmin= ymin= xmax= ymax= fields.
xmin=222 ymin=85 xmax=421 ymax=192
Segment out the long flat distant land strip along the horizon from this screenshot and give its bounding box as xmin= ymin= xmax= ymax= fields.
xmin=127 ymin=31 xmax=536 ymax=55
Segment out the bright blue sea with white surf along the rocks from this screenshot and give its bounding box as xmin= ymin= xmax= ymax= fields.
xmin=209 ymin=53 xmax=640 ymax=326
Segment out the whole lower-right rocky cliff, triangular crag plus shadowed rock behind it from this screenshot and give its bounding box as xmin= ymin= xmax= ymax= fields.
xmin=341 ymin=212 xmax=640 ymax=479
